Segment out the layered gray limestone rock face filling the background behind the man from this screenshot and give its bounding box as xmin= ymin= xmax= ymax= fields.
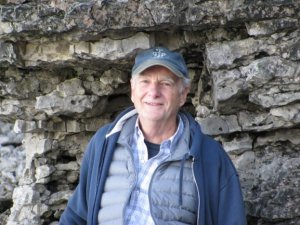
xmin=0 ymin=0 xmax=300 ymax=225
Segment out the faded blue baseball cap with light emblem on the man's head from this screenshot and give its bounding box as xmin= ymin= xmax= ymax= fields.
xmin=131 ymin=47 xmax=189 ymax=78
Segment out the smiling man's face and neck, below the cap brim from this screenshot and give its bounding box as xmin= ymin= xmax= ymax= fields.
xmin=131 ymin=66 xmax=189 ymax=144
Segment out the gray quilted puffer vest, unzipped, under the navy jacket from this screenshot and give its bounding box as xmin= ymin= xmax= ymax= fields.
xmin=98 ymin=116 xmax=198 ymax=225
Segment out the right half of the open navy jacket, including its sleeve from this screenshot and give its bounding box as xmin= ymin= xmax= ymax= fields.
xmin=190 ymin=114 xmax=247 ymax=225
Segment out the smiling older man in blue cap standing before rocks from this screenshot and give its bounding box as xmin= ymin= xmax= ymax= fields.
xmin=60 ymin=47 xmax=246 ymax=225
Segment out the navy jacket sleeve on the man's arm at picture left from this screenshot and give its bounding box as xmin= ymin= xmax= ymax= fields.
xmin=59 ymin=134 xmax=94 ymax=225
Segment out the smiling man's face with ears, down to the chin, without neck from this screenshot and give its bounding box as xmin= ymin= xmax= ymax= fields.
xmin=131 ymin=66 xmax=189 ymax=123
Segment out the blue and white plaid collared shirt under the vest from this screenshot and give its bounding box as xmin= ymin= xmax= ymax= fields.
xmin=125 ymin=117 xmax=184 ymax=225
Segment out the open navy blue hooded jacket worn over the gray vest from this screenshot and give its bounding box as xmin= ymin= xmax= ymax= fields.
xmin=59 ymin=108 xmax=246 ymax=225
